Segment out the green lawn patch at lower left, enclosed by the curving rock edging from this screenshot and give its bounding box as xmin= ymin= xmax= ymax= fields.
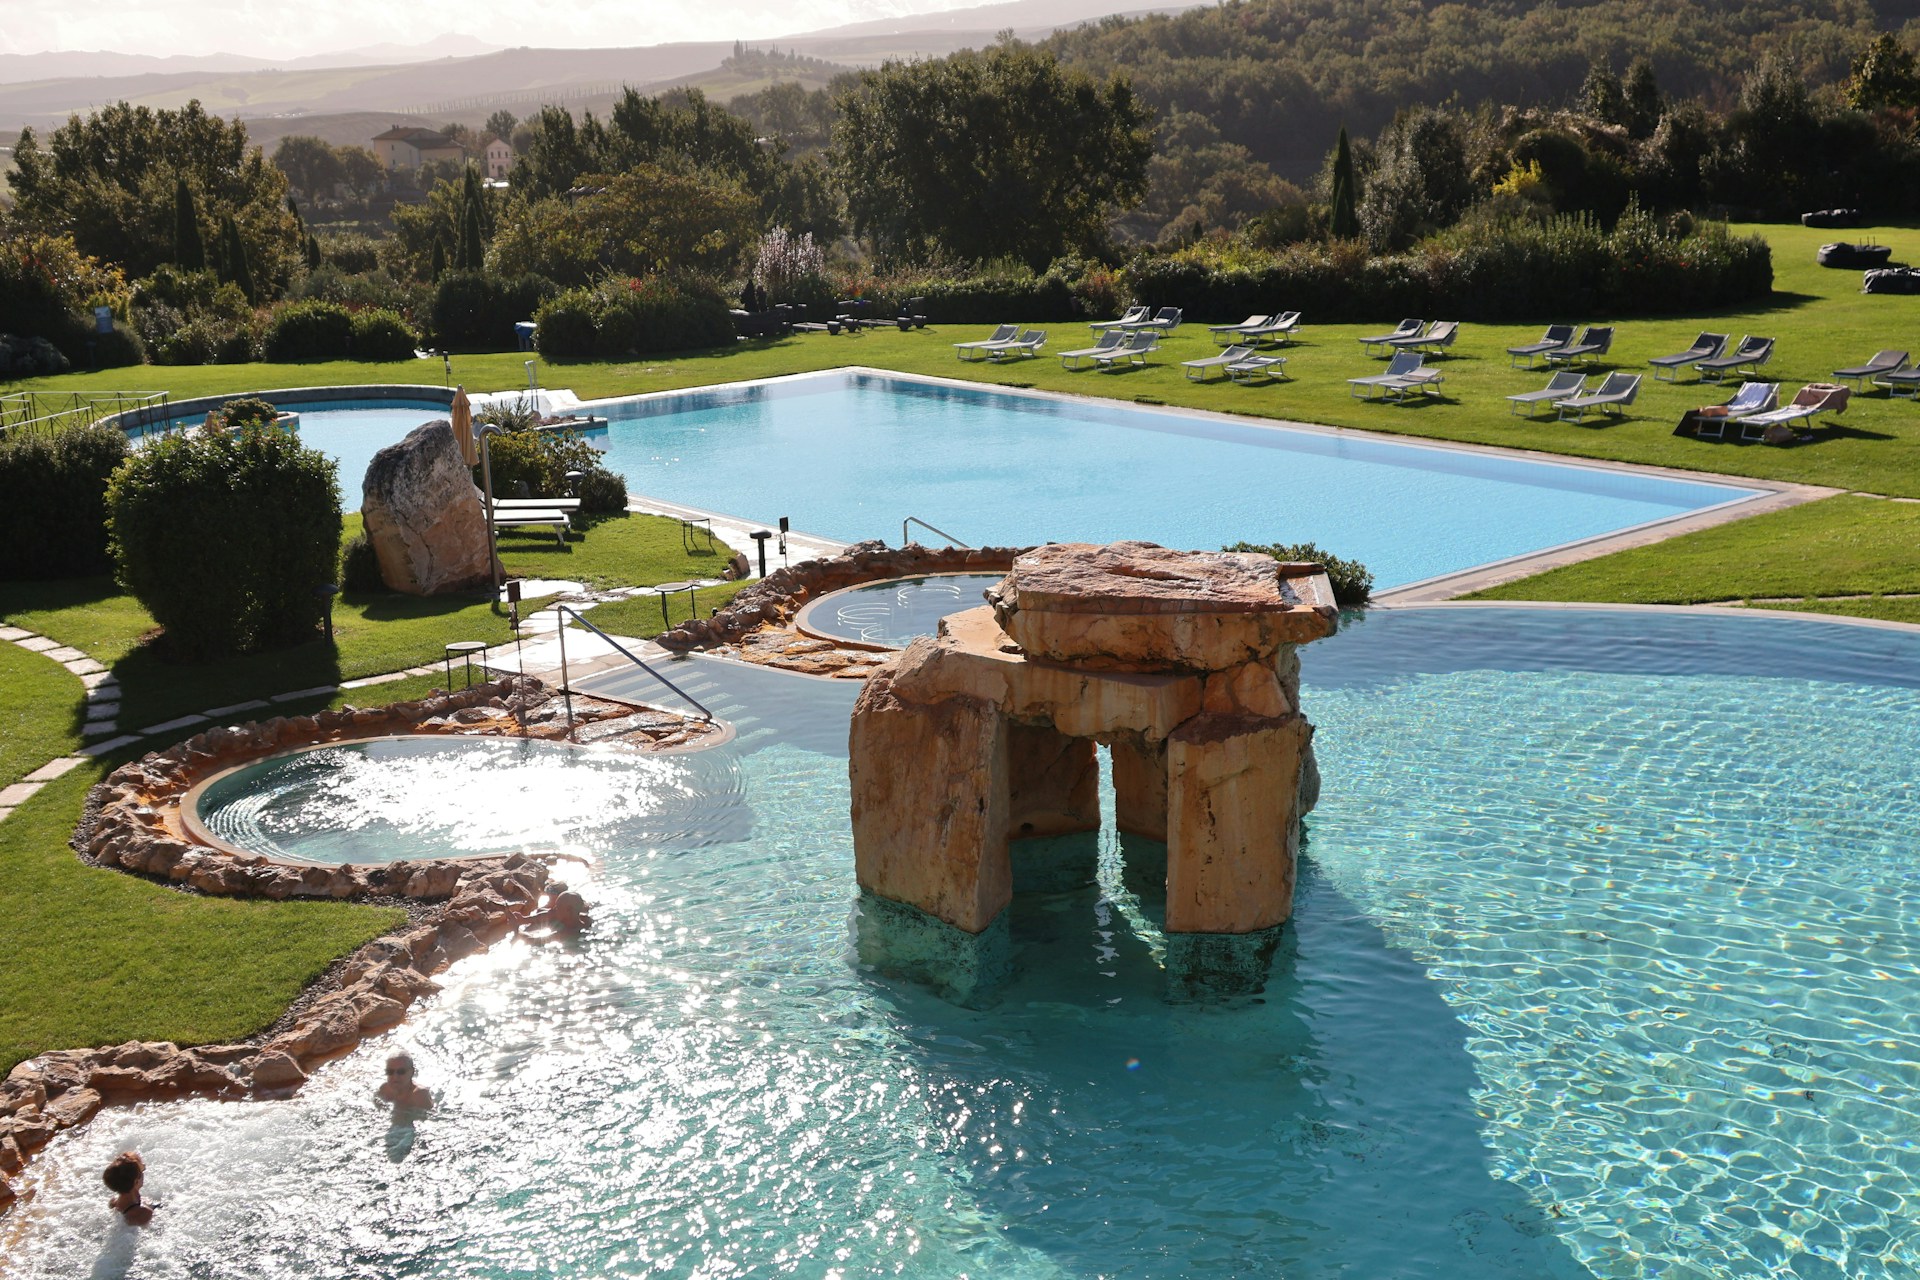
xmin=0 ymin=766 xmax=403 ymax=1073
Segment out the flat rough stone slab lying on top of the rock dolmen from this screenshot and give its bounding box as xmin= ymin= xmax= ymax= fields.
xmin=987 ymin=541 xmax=1338 ymax=672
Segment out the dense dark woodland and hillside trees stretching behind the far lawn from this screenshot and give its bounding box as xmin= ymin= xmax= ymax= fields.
xmin=0 ymin=0 xmax=1920 ymax=376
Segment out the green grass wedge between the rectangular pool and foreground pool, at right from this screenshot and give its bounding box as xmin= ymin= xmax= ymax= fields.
xmin=1473 ymin=495 xmax=1920 ymax=616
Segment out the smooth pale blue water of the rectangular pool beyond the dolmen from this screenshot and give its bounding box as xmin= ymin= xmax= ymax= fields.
xmin=593 ymin=372 xmax=1751 ymax=587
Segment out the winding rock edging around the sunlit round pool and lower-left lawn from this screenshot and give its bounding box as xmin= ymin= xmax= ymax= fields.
xmin=0 ymin=676 xmax=672 ymax=1213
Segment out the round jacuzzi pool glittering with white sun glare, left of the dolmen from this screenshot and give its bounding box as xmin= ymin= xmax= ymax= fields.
xmin=184 ymin=737 xmax=739 ymax=865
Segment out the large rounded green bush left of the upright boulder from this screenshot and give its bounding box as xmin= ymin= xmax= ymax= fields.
xmin=108 ymin=426 xmax=340 ymax=660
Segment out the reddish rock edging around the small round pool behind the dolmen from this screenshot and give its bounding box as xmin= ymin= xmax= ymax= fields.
xmin=655 ymin=539 xmax=1029 ymax=651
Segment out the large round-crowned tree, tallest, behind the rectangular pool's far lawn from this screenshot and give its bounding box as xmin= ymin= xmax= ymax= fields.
xmin=833 ymin=42 xmax=1154 ymax=267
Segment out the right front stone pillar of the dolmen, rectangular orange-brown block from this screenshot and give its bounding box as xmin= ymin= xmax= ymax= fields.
xmin=1165 ymin=714 xmax=1311 ymax=933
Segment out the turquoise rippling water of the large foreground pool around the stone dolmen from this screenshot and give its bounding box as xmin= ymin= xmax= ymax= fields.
xmin=0 ymin=610 xmax=1920 ymax=1280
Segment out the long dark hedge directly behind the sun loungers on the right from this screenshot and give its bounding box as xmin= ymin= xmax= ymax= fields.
xmin=1125 ymin=209 xmax=1774 ymax=322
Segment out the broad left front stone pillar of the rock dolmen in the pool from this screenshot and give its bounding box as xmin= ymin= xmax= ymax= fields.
xmin=849 ymin=670 xmax=1014 ymax=933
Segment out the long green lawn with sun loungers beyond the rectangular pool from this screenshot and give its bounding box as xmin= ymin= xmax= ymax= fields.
xmin=21 ymin=226 xmax=1920 ymax=498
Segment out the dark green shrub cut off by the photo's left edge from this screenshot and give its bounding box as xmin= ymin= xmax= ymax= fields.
xmin=0 ymin=424 xmax=127 ymax=580
